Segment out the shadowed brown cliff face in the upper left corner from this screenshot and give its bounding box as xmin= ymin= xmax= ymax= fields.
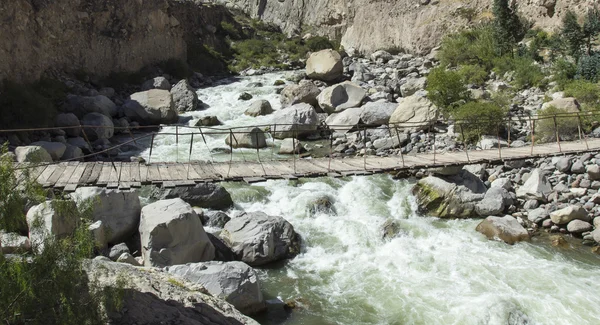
xmin=0 ymin=0 xmax=231 ymax=82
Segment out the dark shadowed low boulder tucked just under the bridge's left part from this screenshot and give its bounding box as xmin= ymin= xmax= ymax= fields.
xmin=151 ymin=183 xmax=233 ymax=210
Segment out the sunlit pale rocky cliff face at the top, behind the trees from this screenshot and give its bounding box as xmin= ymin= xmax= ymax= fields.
xmin=224 ymin=0 xmax=596 ymax=54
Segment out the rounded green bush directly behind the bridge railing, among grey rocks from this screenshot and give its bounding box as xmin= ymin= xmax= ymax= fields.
xmin=452 ymin=102 xmax=506 ymax=143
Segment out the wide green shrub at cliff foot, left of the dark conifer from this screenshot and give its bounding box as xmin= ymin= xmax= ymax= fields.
xmin=438 ymin=26 xmax=497 ymax=68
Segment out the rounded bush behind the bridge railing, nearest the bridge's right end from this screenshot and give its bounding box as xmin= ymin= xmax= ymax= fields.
xmin=535 ymin=106 xmax=579 ymax=143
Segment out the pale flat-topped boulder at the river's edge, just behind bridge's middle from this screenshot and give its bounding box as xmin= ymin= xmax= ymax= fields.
xmin=271 ymin=103 xmax=319 ymax=139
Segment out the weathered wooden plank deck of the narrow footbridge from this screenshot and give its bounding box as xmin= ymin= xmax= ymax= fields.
xmin=14 ymin=139 xmax=600 ymax=191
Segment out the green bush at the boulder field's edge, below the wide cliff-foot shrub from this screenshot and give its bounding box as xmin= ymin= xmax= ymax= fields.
xmin=427 ymin=67 xmax=469 ymax=115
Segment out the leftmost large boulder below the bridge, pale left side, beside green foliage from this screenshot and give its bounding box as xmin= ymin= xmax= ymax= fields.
xmin=26 ymin=200 xmax=79 ymax=250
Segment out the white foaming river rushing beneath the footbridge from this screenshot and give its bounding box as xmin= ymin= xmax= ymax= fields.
xmin=144 ymin=74 xmax=600 ymax=325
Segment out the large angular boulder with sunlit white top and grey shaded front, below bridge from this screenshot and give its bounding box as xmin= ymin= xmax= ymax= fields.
xmin=139 ymin=198 xmax=215 ymax=267
